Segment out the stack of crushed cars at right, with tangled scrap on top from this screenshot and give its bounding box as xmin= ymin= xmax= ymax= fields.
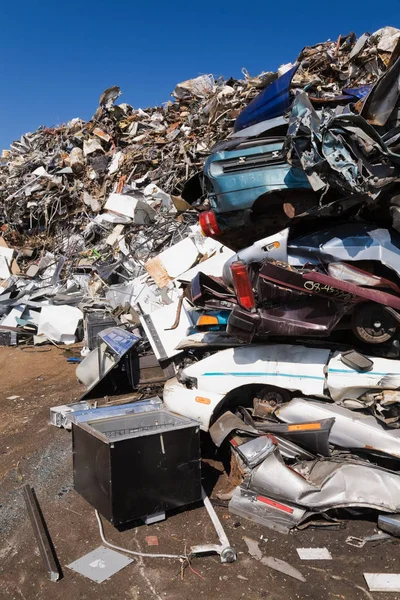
xmin=164 ymin=28 xmax=400 ymax=535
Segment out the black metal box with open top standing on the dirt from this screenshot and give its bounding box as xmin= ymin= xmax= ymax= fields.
xmin=72 ymin=408 xmax=202 ymax=525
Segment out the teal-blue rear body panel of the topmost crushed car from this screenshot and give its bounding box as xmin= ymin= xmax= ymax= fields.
xmin=204 ymin=140 xmax=311 ymax=214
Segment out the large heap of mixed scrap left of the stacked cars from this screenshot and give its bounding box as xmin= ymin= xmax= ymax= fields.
xmin=0 ymin=68 xmax=274 ymax=343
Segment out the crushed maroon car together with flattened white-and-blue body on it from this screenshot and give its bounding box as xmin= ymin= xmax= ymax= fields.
xmin=187 ymin=222 xmax=400 ymax=346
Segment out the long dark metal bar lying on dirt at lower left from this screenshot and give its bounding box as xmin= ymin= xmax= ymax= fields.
xmin=22 ymin=484 xmax=60 ymax=581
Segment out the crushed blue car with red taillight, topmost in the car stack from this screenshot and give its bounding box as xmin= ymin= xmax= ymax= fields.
xmin=199 ymin=65 xmax=372 ymax=244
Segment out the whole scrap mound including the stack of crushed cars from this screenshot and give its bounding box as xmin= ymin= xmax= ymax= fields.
xmin=7 ymin=27 xmax=400 ymax=544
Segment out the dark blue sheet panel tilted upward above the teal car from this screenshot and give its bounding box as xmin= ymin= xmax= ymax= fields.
xmin=234 ymin=64 xmax=299 ymax=131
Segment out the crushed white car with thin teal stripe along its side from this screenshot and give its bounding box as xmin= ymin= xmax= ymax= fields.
xmin=163 ymin=343 xmax=400 ymax=431
